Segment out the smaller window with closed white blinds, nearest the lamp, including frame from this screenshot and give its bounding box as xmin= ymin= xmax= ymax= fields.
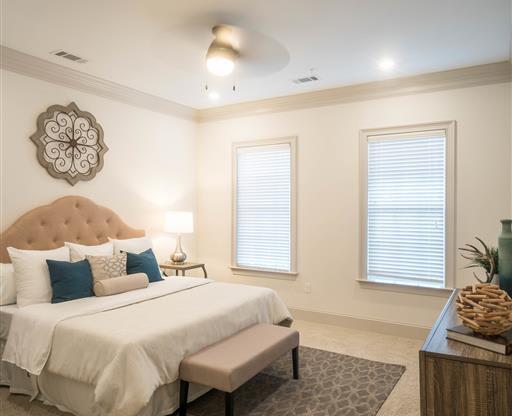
xmin=232 ymin=137 xmax=296 ymax=274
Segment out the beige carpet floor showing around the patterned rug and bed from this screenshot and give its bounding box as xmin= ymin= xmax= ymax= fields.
xmin=0 ymin=321 xmax=422 ymax=416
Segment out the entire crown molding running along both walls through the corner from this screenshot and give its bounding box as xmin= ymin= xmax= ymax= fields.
xmin=0 ymin=45 xmax=511 ymax=123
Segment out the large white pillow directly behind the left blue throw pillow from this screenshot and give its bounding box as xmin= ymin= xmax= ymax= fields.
xmin=7 ymin=246 xmax=69 ymax=308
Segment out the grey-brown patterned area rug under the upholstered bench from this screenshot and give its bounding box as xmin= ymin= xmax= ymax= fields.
xmin=187 ymin=347 xmax=405 ymax=416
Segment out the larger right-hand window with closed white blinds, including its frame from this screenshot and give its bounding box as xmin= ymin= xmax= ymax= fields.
xmin=361 ymin=122 xmax=455 ymax=288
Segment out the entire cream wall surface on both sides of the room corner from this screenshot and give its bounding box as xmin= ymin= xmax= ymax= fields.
xmin=0 ymin=66 xmax=512 ymax=326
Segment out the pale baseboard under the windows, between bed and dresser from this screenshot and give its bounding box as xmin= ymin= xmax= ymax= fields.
xmin=289 ymin=307 xmax=430 ymax=340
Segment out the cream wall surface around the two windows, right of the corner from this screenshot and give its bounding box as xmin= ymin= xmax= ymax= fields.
xmin=197 ymin=84 xmax=511 ymax=326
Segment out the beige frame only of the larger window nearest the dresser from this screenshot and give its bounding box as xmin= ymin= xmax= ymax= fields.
xmin=357 ymin=120 xmax=456 ymax=293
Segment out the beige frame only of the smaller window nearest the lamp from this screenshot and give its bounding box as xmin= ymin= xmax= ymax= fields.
xmin=230 ymin=136 xmax=298 ymax=279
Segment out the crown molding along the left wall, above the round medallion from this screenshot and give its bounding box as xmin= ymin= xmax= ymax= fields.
xmin=0 ymin=45 xmax=197 ymax=121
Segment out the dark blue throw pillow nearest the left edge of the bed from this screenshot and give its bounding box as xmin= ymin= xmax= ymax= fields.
xmin=46 ymin=260 xmax=94 ymax=303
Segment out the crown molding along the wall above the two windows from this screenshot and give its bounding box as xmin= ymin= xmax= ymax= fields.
xmin=198 ymin=61 xmax=511 ymax=123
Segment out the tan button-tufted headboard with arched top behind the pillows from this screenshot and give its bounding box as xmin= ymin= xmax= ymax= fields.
xmin=0 ymin=196 xmax=145 ymax=263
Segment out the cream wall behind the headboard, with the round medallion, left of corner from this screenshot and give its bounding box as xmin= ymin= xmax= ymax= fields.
xmin=1 ymin=71 xmax=197 ymax=262
